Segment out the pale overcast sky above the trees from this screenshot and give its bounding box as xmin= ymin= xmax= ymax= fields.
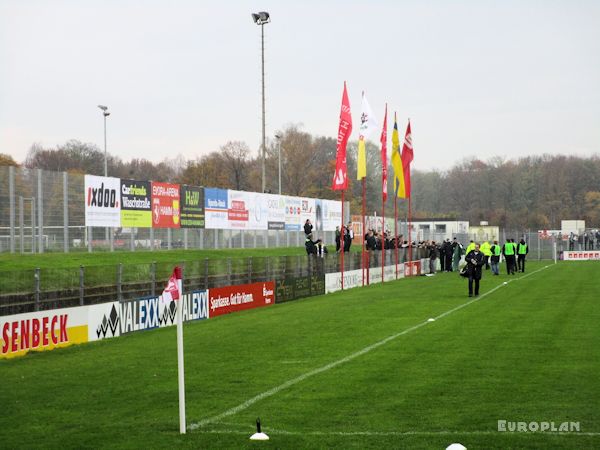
xmin=0 ymin=0 xmax=600 ymax=170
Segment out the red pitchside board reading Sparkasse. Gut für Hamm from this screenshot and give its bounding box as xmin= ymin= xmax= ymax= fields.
xmin=208 ymin=281 xmax=275 ymax=317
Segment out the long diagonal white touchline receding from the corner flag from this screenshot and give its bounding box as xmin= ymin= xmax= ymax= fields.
xmin=188 ymin=266 xmax=549 ymax=430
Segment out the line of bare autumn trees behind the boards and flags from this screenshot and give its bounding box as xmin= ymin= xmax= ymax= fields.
xmin=0 ymin=125 xmax=600 ymax=230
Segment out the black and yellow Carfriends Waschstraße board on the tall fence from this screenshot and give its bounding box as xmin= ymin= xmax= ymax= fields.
xmin=121 ymin=180 xmax=152 ymax=228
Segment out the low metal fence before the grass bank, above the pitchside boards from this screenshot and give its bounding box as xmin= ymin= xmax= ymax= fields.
xmin=0 ymin=249 xmax=426 ymax=316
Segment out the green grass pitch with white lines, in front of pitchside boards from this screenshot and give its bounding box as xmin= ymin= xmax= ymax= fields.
xmin=0 ymin=262 xmax=600 ymax=449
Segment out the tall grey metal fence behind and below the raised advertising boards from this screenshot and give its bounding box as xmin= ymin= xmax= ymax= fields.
xmin=0 ymin=166 xmax=335 ymax=253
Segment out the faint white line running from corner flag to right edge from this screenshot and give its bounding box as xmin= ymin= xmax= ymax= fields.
xmin=200 ymin=427 xmax=600 ymax=436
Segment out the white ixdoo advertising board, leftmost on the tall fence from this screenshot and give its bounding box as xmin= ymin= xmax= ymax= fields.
xmin=84 ymin=175 xmax=121 ymax=227
